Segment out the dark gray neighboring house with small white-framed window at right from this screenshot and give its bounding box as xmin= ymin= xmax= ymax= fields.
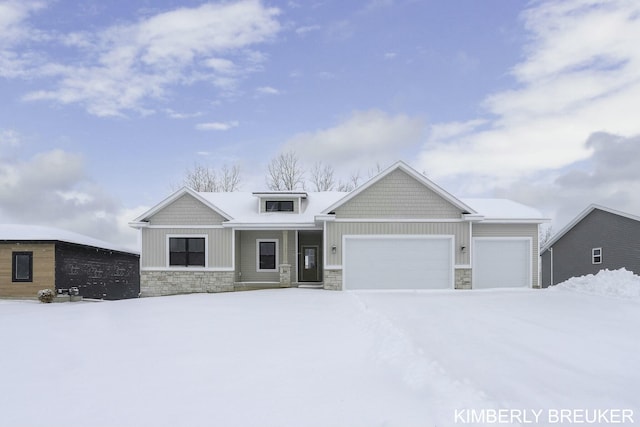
xmin=541 ymin=205 xmax=640 ymax=288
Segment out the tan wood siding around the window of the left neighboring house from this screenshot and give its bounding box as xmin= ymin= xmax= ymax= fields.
xmin=0 ymin=243 xmax=56 ymax=298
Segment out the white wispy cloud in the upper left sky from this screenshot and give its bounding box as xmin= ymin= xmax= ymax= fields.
xmin=5 ymin=0 xmax=280 ymax=116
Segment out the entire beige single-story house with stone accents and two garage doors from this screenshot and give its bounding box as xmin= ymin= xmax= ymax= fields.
xmin=131 ymin=162 xmax=545 ymax=296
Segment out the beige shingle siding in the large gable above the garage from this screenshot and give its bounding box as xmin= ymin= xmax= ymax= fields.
xmin=335 ymin=170 xmax=462 ymax=219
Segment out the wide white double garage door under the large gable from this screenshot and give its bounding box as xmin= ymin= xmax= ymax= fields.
xmin=343 ymin=236 xmax=453 ymax=289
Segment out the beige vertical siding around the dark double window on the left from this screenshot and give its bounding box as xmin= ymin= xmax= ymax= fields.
xmin=141 ymin=228 xmax=233 ymax=269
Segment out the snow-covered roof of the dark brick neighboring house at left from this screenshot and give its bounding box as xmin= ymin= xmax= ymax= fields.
xmin=0 ymin=224 xmax=138 ymax=254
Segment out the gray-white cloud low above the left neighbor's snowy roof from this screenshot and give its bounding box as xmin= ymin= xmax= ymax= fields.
xmin=0 ymin=149 xmax=140 ymax=248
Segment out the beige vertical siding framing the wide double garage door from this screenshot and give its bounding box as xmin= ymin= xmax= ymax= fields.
xmin=325 ymin=222 xmax=470 ymax=266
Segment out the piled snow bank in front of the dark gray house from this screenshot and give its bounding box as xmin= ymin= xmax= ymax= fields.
xmin=550 ymin=268 xmax=640 ymax=300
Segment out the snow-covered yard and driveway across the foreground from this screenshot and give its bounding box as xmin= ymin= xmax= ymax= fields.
xmin=0 ymin=272 xmax=640 ymax=427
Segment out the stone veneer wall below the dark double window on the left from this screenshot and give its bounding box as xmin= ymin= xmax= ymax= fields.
xmin=140 ymin=271 xmax=235 ymax=297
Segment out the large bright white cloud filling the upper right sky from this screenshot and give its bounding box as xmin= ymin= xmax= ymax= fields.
xmin=420 ymin=0 xmax=640 ymax=191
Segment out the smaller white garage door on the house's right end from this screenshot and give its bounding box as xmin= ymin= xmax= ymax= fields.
xmin=472 ymin=238 xmax=531 ymax=289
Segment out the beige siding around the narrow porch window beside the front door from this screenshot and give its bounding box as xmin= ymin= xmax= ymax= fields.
xmin=236 ymin=230 xmax=298 ymax=283
